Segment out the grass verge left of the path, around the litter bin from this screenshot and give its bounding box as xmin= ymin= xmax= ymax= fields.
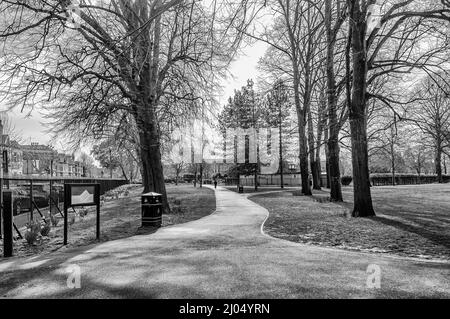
xmin=0 ymin=185 xmax=216 ymax=258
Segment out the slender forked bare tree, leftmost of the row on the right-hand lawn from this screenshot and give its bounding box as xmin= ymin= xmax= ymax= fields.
xmin=255 ymin=0 xmax=323 ymax=195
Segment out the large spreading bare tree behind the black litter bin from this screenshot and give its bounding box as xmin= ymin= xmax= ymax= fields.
xmin=0 ymin=0 xmax=253 ymax=211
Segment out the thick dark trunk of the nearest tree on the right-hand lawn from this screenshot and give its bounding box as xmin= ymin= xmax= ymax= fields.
xmin=347 ymin=0 xmax=375 ymax=217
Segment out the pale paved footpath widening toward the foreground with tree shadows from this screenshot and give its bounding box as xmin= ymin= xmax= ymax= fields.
xmin=0 ymin=187 xmax=450 ymax=298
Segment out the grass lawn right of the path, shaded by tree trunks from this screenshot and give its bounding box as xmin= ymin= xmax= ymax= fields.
xmin=251 ymin=184 xmax=450 ymax=260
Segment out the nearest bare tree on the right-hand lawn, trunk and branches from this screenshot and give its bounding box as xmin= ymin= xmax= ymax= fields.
xmin=347 ymin=0 xmax=450 ymax=217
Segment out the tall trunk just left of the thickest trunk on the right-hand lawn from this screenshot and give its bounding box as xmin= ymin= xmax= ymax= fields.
xmin=325 ymin=0 xmax=343 ymax=202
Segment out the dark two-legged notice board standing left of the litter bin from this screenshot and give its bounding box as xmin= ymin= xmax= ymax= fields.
xmin=64 ymin=183 xmax=100 ymax=245
